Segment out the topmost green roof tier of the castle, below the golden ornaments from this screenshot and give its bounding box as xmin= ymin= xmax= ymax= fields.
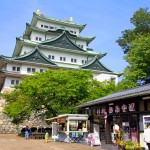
xmin=31 ymin=12 xmax=86 ymax=32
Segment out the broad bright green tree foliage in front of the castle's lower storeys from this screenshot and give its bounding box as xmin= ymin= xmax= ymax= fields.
xmin=2 ymin=70 xmax=118 ymax=123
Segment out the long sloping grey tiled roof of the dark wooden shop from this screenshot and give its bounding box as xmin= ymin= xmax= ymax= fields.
xmin=77 ymin=84 xmax=150 ymax=108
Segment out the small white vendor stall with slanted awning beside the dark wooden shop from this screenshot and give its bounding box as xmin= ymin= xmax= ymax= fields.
xmin=46 ymin=114 xmax=88 ymax=142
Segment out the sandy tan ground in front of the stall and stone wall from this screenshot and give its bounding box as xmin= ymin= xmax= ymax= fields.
xmin=0 ymin=134 xmax=117 ymax=150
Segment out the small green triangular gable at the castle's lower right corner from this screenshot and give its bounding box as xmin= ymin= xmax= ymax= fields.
xmin=80 ymin=54 xmax=112 ymax=72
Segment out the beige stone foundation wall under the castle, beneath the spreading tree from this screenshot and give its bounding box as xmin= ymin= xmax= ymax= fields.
xmin=0 ymin=98 xmax=50 ymax=134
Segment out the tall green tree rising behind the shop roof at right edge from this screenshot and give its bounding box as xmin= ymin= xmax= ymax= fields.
xmin=116 ymin=8 xmax=150 ymax=89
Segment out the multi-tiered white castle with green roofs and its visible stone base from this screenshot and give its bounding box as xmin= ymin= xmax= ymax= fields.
xmin=0 ymin=10 xmax=119 ymax=133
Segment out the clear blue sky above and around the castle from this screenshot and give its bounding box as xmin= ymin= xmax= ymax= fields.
xmin=0 ymin=0 xmax=150 ymax=72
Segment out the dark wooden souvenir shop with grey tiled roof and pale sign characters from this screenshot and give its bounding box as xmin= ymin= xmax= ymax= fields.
xmin=77 ymin=84 xmax=150 ymax=147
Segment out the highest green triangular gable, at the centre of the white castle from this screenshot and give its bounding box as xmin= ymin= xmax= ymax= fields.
xmin=41 ymin=31 xmax=86 ymax=52
